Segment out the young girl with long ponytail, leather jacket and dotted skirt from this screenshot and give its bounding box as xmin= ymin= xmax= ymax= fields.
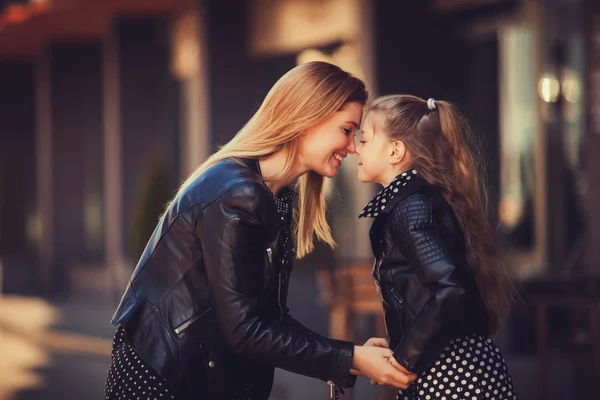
xmin=357 ymin=95 xmax=517 ymax=400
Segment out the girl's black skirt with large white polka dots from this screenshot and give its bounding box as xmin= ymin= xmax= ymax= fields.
xmin=396 ymin=335 xmax=517 ymax=400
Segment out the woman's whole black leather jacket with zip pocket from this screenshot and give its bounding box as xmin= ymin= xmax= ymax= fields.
xmin=112 ymin=159 xmax=355 ymax=400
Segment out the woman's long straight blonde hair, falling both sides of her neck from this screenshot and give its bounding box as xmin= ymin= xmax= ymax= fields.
xmin=179 ymin=61 xmax=368 ymax=258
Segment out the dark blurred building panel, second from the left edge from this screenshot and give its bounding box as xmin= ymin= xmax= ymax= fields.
xmin=36 ymin=41 xmax=103 ymax=292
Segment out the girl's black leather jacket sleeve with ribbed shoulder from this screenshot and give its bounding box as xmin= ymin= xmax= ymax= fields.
xmin=392 ymin=195 xmax=465 ymax=375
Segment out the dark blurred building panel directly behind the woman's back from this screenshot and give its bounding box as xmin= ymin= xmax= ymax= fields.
xmin=104 ymin=16 xmax=180 ymax=292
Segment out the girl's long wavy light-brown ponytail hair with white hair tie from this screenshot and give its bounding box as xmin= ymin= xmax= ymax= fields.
xmin=368 ymin=95 xmax=515 ymax=333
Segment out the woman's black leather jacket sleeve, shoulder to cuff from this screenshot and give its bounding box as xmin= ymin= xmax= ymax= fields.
xmin=196 ymin=186 xmax=355 ymax=387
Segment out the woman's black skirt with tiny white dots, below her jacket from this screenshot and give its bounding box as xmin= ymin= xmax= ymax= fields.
xmin=104 ymin=326 xmax=175 ymax=400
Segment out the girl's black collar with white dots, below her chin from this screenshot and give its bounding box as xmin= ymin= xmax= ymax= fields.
xmin=358 ymin=169 xmax=424 ymax=218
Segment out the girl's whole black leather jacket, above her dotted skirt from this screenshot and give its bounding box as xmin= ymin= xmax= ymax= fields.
xmin=370 ymin=176 xmax=489 ymax=375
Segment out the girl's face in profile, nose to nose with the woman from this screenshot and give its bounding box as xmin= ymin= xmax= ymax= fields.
xmin=356 ymin=113 xmax=395 ymax=186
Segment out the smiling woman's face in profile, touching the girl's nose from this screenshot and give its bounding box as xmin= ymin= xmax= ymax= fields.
xmin=298 ymin=102 xmax=363 ymax=178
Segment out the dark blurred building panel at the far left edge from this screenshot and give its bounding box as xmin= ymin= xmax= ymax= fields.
xmin=0 ymin=60 xmax=37 ymax=293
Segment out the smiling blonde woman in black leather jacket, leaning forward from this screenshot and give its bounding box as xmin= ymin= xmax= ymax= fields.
xmin=106 ymin=62 xmax=411 ymax=400
